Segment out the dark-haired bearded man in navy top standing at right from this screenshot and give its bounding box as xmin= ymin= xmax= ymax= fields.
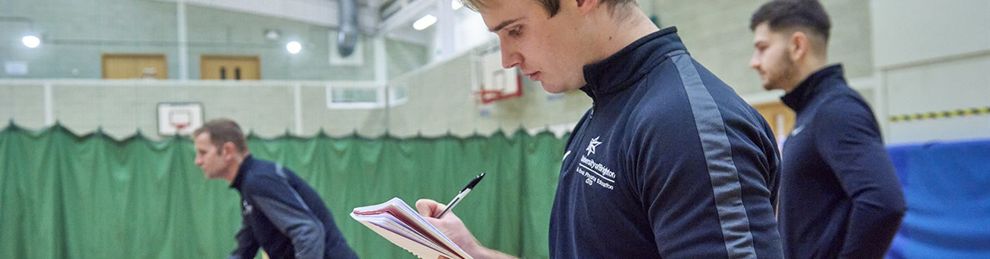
xmin=751 ymin=1 xmax=905 ymax=258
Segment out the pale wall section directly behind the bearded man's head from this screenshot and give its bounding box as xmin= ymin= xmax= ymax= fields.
xmin=660 ymin=0 xmax=874 ymax=99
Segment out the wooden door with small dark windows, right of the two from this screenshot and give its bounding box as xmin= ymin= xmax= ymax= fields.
xmin=199 ymin=55 xmax=261 ymax=80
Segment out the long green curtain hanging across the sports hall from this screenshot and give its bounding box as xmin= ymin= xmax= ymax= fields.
xmin=0 ymin=124 xmax=564 ymax=258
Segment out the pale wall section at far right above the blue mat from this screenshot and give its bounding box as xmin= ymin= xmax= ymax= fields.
xmin=870 ymin=0 xmax=990 ymax=143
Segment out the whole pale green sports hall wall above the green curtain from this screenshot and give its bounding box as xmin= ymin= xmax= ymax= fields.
xmin=0 ymin=0 xmax=990 ymax=142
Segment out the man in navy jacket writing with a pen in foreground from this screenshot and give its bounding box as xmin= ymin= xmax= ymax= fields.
xmin=416 ymin=0 xmax=783 ymax=258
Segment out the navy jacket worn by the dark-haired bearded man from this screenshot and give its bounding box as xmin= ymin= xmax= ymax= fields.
xmin=780 ymin=65 xmax=905 ymax=258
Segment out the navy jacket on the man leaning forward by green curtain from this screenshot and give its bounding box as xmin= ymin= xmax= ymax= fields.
xmin=231 ymin=155 xmax=357 ymax=259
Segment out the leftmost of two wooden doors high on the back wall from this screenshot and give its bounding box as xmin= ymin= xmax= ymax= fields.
xmin=103 ymin=54 xmax=168 ymax=79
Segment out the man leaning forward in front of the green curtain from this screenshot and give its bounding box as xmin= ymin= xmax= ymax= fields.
xmin=193 ymin=119 xmax=357 ymax=258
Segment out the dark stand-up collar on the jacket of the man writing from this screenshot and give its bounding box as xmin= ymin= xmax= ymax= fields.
xmin=581 ymin=27 xmax=686 ymax=100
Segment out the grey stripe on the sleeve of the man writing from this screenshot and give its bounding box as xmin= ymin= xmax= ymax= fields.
xmin=671 ymin=54 xmax=756 ymax=258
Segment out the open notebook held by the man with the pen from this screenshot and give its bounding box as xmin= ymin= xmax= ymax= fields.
xmin=351 ymin=198 xmax=471 ymax=259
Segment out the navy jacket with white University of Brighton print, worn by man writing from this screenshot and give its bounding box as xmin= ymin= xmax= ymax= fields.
xmin=550 ymin=28 xmax=782 ymax=258
